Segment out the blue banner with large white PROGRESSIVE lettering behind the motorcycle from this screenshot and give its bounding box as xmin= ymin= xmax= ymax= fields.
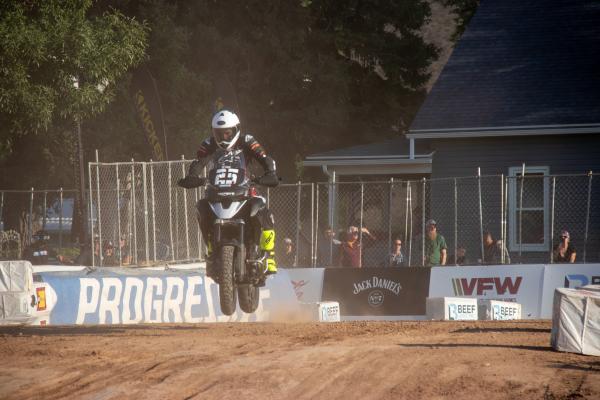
xmin=38 ymin=268 xmax=298 ymax=325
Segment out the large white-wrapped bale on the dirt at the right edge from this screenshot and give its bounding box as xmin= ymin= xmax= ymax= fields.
xmin=551 ymin=285 xmax=600 ymax=356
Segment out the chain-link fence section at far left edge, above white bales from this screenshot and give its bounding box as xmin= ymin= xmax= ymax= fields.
xmin=0 ymin=188 xmax=77 ymax=259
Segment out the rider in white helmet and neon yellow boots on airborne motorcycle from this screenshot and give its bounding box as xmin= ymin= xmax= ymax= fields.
xmin=178 ymin=110 xmax=279 ymax=277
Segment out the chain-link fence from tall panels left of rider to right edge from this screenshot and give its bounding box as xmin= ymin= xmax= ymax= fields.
xmin=90 ymin=160 xmax=600 ymax=267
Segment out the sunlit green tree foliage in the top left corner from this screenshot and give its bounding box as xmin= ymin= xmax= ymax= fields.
xmin=0 ymin=0 xmax=147 ymax=141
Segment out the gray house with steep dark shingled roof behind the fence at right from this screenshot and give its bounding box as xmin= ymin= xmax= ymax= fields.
xmin=305 ymin=0 xmax=600 ymax=262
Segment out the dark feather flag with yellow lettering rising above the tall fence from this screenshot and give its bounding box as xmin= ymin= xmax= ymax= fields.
xmin=131 ymin=67 xmax=168 ymax=161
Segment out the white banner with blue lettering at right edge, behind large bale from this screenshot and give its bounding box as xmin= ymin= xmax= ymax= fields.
xmin=541 ymin=264 xmax=600 ymax=318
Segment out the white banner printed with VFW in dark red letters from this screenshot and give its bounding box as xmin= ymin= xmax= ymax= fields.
xmin=429 ymin=265 xmax=544 ymax=318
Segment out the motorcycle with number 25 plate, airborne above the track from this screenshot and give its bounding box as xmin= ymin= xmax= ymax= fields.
xmin=179 ymin=150 xmax=277 ymax=315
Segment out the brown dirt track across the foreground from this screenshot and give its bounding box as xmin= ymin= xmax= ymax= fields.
xmin=0 ymin=322 xmax=600 ymax=400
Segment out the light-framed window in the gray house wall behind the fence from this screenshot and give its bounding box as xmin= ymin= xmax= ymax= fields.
xmin=508 ymin=167 xmax=550 ymax=251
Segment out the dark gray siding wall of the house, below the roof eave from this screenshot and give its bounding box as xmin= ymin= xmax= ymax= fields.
xmin=427 ymin=135 xmax=600 ymax=262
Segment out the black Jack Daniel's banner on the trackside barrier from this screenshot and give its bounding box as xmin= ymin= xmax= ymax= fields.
xmin=323 ymin=268 xmax=431 ymax=316
